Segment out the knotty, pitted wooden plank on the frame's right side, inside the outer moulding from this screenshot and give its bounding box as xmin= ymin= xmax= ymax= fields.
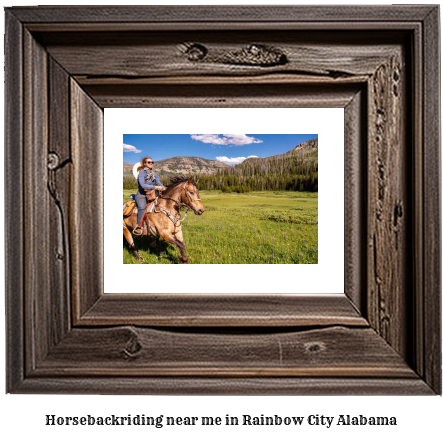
xmin=367 ymin=53 xmax=412 ymax=355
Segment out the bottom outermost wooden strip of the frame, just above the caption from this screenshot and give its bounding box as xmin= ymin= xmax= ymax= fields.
xmin=14 ymin=376 xmax=434 ymax=396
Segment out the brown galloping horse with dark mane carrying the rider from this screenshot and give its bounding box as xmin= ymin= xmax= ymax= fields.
xmin=123 ymin=177 xmax=205 ymax=263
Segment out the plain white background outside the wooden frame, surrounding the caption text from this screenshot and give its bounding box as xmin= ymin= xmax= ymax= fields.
xmin=0 ymin=0 xmax=443 ymax=438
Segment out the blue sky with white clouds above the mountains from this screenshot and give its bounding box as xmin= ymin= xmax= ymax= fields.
xmin=123 ymin=134 xmax=318 ymax=165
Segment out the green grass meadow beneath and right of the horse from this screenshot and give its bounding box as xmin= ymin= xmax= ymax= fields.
xmin=123 ymin=190 xmax=318 ymax=264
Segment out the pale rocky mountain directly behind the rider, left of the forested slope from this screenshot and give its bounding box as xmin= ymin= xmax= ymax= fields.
xmin=123 ymin=157 xmax=229 ymax=179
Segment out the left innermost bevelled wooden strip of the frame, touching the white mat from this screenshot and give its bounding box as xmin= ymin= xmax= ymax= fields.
xmin=69 ymin=79 xmax=104 ymax=320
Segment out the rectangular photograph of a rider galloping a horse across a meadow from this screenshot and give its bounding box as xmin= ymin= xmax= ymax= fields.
xmin=123 ymin=134 xmax=318 ymax=264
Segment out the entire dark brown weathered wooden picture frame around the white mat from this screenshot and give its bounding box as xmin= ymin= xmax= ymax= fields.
xmin=5 ymin=6 xmax=441 ymax=394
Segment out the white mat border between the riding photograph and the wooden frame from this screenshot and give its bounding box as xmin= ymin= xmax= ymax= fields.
xmin=104 ymin=108 xmax=344 ymax=293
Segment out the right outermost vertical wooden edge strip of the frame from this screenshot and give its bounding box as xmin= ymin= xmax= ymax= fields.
xmin=417 ymin=8 xmax=442 ymax=388
